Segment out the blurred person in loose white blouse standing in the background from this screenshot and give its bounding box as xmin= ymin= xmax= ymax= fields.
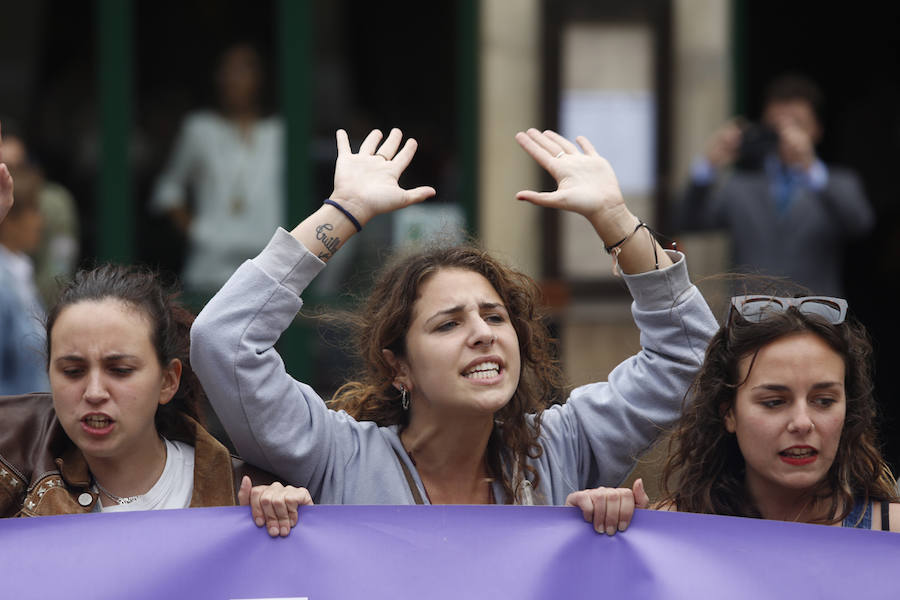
xmin=150 ymin=43 xmax=284 ymax=299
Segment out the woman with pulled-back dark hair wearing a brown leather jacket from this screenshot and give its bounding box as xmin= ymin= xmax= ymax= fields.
xmin=0 ymin=123 xmax=308 ymax=535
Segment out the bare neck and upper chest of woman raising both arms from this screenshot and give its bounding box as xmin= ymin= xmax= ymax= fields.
xmin=400 ymin=415 xmax=494 ymax=504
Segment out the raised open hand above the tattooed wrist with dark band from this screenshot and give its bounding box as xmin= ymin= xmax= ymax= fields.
xmin=331 ymin=129 xmax=435 ymax=225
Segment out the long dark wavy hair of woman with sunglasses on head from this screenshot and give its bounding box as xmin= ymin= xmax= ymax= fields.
xmin=662 ymin=308 xmax=896 ymax=522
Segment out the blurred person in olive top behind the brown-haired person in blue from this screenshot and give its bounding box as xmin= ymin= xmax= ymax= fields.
xmin=3 ymin=120 xmax=79 ymax=306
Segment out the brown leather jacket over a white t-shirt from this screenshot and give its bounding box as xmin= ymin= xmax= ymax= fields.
xmin=0 ymin=394 xmax=275 ymax=517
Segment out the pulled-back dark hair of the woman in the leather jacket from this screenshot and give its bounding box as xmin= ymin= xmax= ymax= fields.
xmin=47 ymin=264 xmax=204 ymax=439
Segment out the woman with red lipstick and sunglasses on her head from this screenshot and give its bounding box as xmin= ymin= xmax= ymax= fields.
xmin=662 ymin=296 xmax=900 ymax=531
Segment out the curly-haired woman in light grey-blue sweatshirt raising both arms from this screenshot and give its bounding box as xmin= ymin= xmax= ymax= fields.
xmin=192 ymin=129 xmax=715 ymax=531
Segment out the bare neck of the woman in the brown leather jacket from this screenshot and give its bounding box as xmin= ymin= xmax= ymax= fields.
xmin=85 ymin=435 xmax=166 ymax=506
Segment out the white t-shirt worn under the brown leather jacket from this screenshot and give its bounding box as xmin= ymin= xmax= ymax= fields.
xmin=95 ymin=439 xmax=194 ymax=512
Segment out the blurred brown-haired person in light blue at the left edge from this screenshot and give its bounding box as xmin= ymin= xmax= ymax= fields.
xmin=0 ymin=141 xmax=49 ymax=395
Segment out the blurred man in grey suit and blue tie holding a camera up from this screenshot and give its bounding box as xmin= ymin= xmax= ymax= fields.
xmin=678 ymin=76 xmax=874 ymax=296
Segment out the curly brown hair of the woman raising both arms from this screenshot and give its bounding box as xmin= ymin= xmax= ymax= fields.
xmin=332 ymin=246 xmax=562 ymax=502
